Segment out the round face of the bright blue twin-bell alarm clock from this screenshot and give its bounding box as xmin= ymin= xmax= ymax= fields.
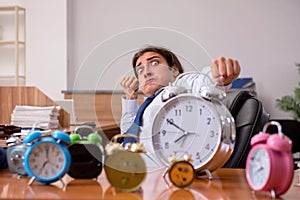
xmin=25 ymin=142 xmax=66 ymax=181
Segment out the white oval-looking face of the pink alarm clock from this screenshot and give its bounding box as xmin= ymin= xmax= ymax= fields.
xmin=247 ymin=147 xmax=271 ymax=190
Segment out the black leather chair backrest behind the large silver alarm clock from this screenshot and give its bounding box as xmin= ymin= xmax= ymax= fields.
xmin=223 ymin=90 xmax=269 ymax=168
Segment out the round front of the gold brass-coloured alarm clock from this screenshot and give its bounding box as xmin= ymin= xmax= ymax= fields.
xmin=104 ymin=151 xmax=146 ymax=192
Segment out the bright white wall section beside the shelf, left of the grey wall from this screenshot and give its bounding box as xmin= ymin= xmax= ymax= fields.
xmin=0 ymin=0 xmax=67 ymax=100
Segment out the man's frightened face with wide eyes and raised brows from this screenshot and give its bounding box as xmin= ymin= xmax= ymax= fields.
xmin=135 ymin=52 xmax=178 ymax=97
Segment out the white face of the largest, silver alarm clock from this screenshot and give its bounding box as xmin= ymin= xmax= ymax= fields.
xmin=152 ymin=94 xmax=222 ymax=169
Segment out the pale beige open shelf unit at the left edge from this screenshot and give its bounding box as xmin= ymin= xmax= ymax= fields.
xmin=0 ymin=6 xmax=26 ymax=86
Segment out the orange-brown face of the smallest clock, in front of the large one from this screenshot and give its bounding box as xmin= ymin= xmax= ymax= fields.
xmin=169 ymin=161 xmax=195 ymax=188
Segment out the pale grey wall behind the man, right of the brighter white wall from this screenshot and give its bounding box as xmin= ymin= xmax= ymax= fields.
xmin=68 ymin=0 xmax=300 ymax=119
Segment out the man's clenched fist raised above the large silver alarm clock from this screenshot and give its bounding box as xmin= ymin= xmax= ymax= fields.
xmin=210 ymin=57 xmax=241 ymax=85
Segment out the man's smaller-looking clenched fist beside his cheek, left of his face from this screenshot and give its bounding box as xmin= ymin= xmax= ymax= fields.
xmin=120 ymin=76 xmax=139 ymax=99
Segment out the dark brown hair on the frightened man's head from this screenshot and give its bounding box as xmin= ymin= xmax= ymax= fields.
xmin=132 ymin=46 xmax=183 ymax=77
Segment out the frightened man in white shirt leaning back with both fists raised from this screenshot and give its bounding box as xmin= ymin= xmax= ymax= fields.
xmin=120 ymin=46 xmax=240 ymax=167
